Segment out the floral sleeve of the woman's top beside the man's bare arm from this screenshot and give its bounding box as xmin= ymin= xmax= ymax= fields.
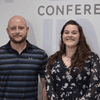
xmin=45 ymin=67 xmax=59 ymax=100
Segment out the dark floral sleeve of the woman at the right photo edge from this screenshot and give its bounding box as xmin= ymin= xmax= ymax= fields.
xmin=79 ymin=54 xmax=100 ymax=100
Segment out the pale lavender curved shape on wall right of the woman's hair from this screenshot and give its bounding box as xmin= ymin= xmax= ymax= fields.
xmin=76 ymin=19 xmax=100 ymax=57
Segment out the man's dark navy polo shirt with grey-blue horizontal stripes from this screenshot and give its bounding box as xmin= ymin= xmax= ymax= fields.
xmin=0 ymin=41 xmax=47 ymax=100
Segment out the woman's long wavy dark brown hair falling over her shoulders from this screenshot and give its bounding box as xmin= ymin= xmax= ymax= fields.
xmin=47 ymin=20 xmax=91 ymax=74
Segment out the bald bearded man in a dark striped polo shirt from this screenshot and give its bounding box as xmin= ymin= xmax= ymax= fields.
xmin=0 ymin=15 xmax=47 ymax=100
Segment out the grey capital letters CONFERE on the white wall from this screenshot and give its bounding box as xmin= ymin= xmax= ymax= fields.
xmin=38 ymin=4 xmax=100 ymax=16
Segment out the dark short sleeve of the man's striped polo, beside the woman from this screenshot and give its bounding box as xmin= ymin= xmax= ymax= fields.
xmin=38 ymin=52 xmax=48 ymax=78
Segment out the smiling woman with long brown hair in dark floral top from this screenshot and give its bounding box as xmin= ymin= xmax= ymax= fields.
xmin=45 ymin=20 xmax=100 ymax=100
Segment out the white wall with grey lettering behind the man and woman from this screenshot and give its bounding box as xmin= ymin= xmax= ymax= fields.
xmin=0 ymin=0 xmax=100 ymax=100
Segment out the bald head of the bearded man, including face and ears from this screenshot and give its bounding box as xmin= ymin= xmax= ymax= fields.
xmin=6 ymin=15 xmax=29 ymax=43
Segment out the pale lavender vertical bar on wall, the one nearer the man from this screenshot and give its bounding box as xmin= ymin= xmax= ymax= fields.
xmin=43 ymin=19 xmax=53 ymax=55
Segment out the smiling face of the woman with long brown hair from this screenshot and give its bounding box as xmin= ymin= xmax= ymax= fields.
xmin=62 ymin=24 xmax=80 ymax=47
